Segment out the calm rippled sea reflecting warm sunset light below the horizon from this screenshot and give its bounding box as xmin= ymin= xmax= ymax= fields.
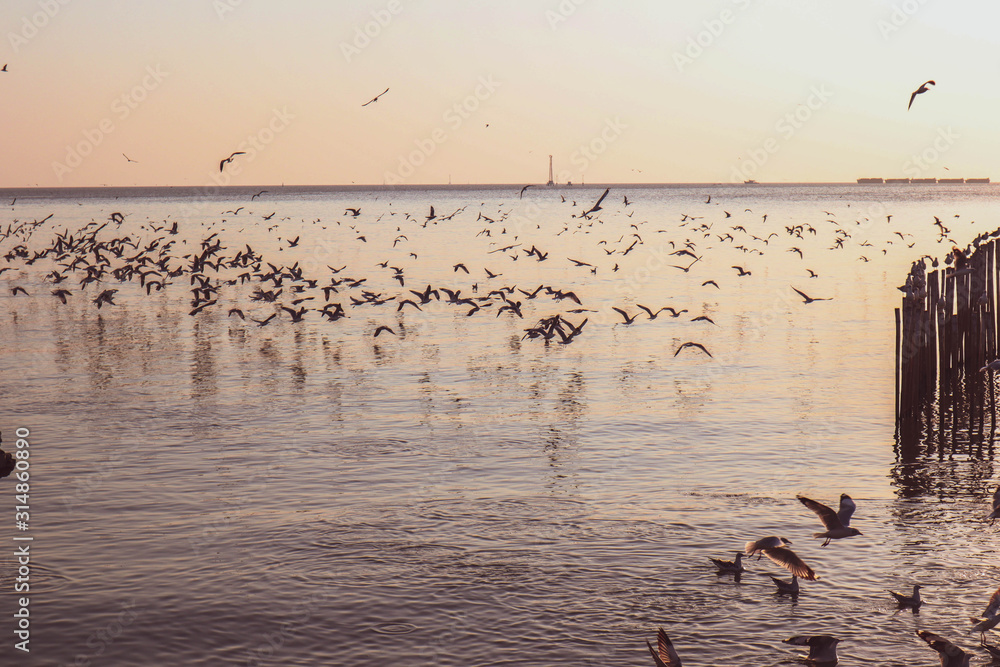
xmin=0 ymin=186 xmax=1000 ymax=667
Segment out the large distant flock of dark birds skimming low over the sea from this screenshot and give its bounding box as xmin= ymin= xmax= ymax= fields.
xmin=0 ymin=177 xmax=976 ymax=376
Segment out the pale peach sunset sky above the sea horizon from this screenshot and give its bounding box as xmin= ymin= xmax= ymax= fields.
xmin=0 ymin=0 xmax=1000 ymax=187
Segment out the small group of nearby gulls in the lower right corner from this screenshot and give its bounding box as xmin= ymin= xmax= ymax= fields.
xmin=646 ymin=487 xmax=1000 ymax=667
